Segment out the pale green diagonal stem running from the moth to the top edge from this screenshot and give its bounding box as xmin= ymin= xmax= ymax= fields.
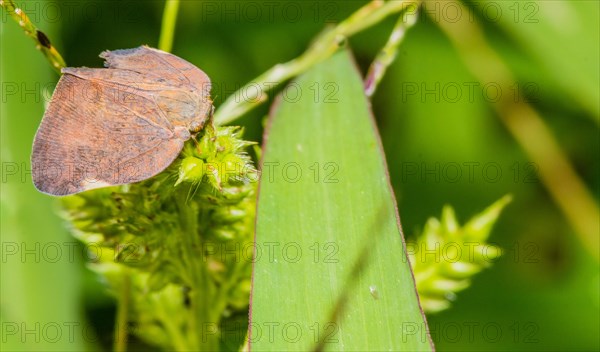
xmin=214 ymin=0 xmax=420 ymax=125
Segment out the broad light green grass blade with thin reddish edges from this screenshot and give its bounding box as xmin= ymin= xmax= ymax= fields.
xmin=249 ymin=51 xmax=433 ymax=351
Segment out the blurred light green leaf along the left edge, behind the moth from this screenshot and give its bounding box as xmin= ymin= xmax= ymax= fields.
xmin=0 ymin=6 xmax=88 ymax=351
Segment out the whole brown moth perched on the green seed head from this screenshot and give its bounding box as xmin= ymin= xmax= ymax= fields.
xmin=31 ymin=46 xmax=212 ymax=196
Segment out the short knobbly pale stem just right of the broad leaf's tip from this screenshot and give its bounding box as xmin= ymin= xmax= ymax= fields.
xmin=365 ymin=3 xmax=419 ymax=97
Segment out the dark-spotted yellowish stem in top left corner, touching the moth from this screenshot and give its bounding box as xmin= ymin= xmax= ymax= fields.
xmin=0 ymin=0 xmax=66 ymax=74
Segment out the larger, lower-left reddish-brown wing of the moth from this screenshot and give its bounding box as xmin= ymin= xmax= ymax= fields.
xmin=32 ymin=74 xmax=189 ymax=195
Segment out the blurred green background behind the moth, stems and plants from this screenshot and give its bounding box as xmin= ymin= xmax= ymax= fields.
xmin=0 ymin=0 xmax=600 ymax=351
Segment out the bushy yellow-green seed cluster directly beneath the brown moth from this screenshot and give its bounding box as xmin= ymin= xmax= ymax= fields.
xmin=63 ymin=124 xmax=256 ymax=350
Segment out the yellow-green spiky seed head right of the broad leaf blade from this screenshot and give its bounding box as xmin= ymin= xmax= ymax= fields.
xmin=407 ymin=196 xmax=511 ymax=313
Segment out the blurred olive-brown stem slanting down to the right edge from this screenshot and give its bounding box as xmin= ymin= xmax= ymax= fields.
xmin=425 ymin=0 xmax=600 ymax=259
